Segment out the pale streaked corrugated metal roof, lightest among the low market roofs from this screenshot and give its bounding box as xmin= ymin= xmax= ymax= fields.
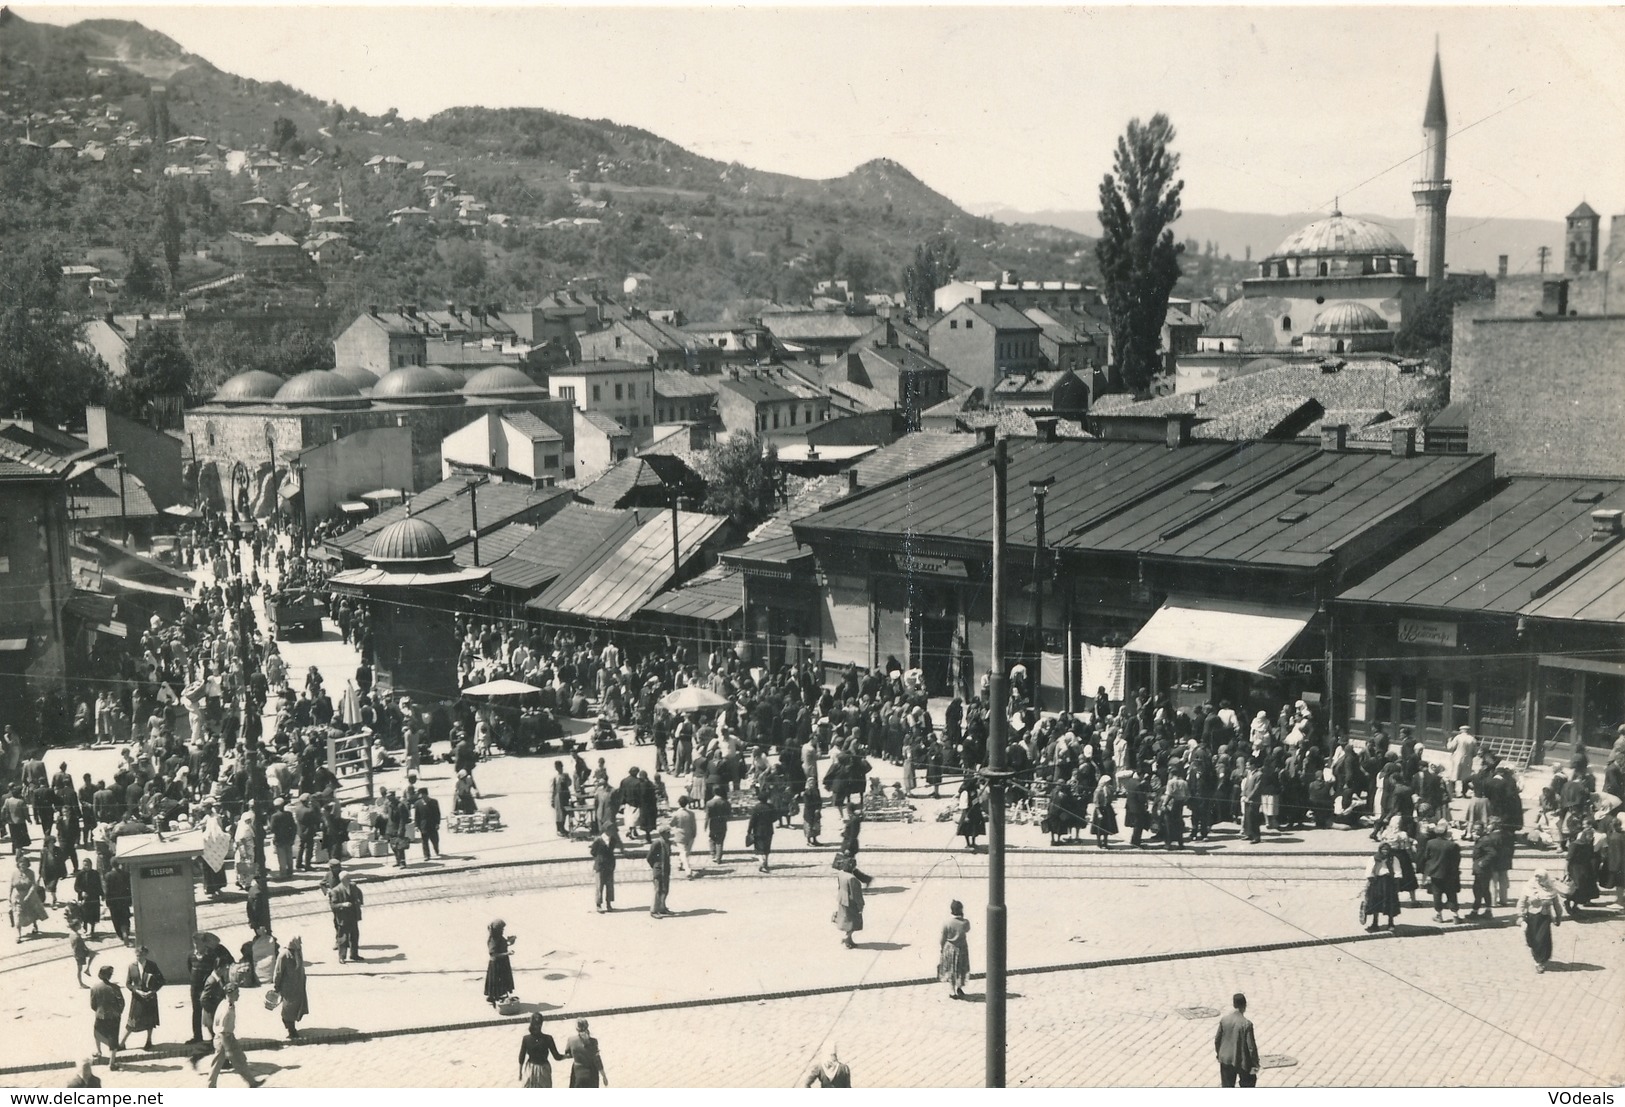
xmin=527 ymin=512 xmax=728 ymax=623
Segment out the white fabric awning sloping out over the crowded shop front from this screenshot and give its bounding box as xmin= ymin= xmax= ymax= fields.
xmin=1125 ymin=597 xmax=1315 ymax=676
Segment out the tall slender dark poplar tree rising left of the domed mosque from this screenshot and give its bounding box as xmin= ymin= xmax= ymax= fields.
xmin=1095 ymin=112 xmax=1185 ymax=392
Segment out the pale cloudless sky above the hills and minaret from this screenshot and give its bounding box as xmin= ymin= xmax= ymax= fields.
xmin=15 ymin=0 xmax=1625 ymax=219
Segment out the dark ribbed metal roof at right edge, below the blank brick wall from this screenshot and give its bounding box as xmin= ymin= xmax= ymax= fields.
xmin=1339 ymin=478 xmax=1625 ymax=623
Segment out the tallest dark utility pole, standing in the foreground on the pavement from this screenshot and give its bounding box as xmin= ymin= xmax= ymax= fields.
xmin=985 ymin=437 xmax=1009 ymax=1087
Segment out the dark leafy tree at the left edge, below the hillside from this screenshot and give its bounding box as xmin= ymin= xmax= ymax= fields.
xmin=0 ymin=245 xmax=107 ymax=423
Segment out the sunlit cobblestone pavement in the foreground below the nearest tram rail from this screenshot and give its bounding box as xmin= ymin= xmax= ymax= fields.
xmin=11 ymin=925 xmax=1625 ymax=1087
